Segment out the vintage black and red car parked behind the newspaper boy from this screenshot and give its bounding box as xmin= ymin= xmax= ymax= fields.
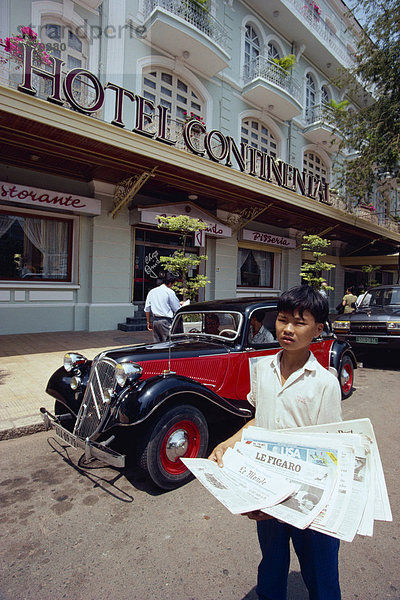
xmin=41 ymin=298 xmax=356 ymax=489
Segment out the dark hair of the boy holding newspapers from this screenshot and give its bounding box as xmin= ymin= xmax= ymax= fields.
xmin=278 ymin=285 xmax=329 ymax=323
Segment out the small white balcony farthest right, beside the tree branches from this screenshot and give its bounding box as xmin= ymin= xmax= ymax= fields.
xmin=303 ymin=104 xmax=342 ymax=152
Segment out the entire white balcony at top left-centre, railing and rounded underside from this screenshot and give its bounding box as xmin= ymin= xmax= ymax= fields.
xmin=144 ymin=0 xmax=230 ymax=77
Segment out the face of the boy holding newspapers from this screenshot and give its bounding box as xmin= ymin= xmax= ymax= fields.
xmin=275 ymin=309 xmax=324 ymax=352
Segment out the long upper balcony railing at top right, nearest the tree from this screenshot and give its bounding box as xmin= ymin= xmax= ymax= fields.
xmin=287 ymin=0 xmax=354 ymax=67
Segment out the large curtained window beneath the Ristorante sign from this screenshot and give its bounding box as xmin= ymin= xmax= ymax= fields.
xmin=0 ymin=212 xmax=73 ymax=281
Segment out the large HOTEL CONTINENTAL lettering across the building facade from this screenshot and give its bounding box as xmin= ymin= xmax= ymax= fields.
xmin=18 ymin=44 xmax=330 ymax=204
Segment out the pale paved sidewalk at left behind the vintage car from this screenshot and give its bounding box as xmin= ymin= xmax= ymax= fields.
xmin=0 ymin=330 xmax=153 ymax=440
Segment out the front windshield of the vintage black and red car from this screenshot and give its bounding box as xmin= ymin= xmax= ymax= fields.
xmin=171 ymin=311 xmax=243 ymax=340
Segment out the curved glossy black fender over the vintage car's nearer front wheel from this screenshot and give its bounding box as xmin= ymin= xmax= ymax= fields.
xmin=114 ymin=374 xmax=253 ymax=427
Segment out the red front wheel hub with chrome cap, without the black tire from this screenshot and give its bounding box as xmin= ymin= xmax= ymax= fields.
xmin=161 ymin=420 xmax=201 ymax=475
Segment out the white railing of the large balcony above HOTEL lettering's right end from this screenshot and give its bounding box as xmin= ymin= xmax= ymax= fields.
xmin=144 ymin=0 xmax=228 ymax=51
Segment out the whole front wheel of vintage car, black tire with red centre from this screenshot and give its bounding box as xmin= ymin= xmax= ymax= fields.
xmin=138 ymin=404 xmax=208 ymax=490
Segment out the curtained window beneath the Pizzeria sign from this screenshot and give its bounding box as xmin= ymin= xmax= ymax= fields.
xmin=237 ymin=248 xmax=274 ymax=287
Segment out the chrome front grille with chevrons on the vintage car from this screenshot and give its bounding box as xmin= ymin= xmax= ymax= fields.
xmin=74 ymin=358 xmax=117 ymax=439
